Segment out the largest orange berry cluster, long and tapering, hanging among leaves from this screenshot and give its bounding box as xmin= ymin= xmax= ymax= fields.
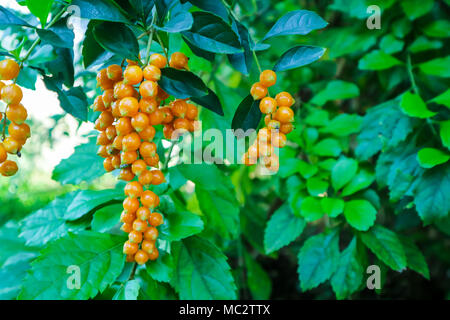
xmin=93 ymin=52 xmax=198 ymax=264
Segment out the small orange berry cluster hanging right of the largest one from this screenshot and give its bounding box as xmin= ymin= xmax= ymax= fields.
xmin=243 ymin=70 xmax=295 ymax=171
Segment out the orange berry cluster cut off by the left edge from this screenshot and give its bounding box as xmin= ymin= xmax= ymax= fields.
xmin=0 ymin=59 xmax=30 ymax=177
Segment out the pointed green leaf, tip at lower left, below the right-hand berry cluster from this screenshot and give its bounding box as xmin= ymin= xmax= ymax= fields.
xmin=264 ymin=204 xmax=306 ymax=254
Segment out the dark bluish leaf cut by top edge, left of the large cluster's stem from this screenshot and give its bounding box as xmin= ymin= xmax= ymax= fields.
xmin=72 ymin=0 xmax=129 ymax=23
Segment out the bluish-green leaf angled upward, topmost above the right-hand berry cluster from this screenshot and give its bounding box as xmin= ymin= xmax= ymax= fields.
xmin=262 ymin=10 xmax=328 ymax=41
